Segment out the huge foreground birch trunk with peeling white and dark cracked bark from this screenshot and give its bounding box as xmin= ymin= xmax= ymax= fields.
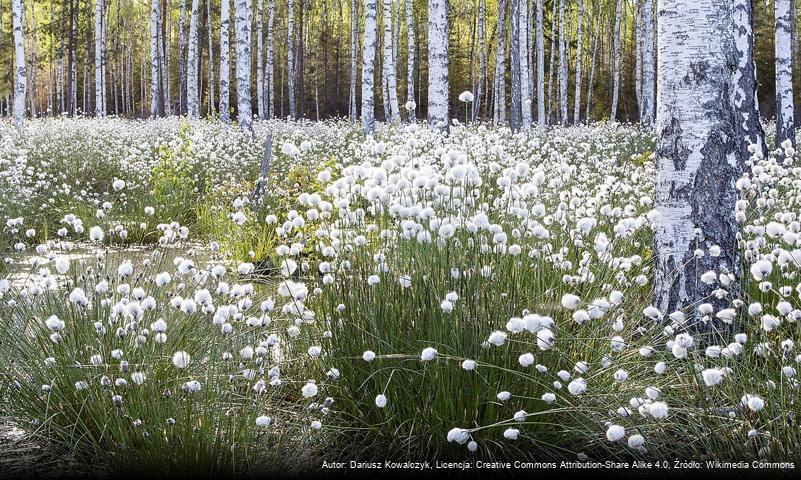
xmin=653 ymin=0 xmax=740 ymax=331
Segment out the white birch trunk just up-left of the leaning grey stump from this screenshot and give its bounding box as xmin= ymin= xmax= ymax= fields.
xmin=234 ymin=0 xmax=253 ymax=131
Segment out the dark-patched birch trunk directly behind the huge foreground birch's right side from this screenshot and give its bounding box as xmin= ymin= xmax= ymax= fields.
xmin=732 ymin=0 xmax=768 ymax=162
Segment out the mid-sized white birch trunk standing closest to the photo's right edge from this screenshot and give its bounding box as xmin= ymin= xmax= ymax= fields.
xmin=775 ymin=0 xmax=795 ymax=148
